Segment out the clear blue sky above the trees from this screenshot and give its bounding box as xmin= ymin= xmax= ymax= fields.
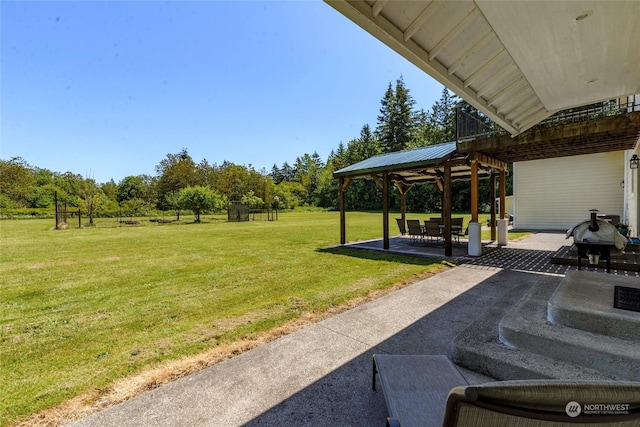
xmin=0 ymin=0 xmax=443 ymax=183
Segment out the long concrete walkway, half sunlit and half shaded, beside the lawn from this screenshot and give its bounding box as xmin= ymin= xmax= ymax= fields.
xmin=72 ymin=233 xmax=608 ymax=427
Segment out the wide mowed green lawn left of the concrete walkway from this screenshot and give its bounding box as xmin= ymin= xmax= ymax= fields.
xmin=0 ymin=212 xmax=450 ymax=425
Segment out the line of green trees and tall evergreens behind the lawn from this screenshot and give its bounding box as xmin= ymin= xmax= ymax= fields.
xmin=0 ymin=77 xmax=510 ymax=220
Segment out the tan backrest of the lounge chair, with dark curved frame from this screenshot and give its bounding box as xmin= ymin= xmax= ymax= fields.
xmin=442 ymin=380 xmax=640 ymax=427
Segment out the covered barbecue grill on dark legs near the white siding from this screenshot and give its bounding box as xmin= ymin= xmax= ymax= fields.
xmin=566 ymin=209 xmax=627 ymax=273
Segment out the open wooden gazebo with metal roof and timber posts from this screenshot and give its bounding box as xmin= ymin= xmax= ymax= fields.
xmin=333 ymin=142 xmax=507 ymax=256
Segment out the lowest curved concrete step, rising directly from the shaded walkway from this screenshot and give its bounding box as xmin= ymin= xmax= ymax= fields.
xmin=451 ymin=276 xmax=618 ymax=380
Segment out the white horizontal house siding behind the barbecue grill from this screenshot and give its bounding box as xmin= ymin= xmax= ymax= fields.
xmin=513 ymin=151 xmax=624 ymax=230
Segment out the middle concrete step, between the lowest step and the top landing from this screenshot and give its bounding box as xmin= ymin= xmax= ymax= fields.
xmin=499 ymin=272 xmax=640 ymax=381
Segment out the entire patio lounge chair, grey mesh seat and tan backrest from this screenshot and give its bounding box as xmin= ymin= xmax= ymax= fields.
xmin=373 ymin=354 xmax=640 ymax=427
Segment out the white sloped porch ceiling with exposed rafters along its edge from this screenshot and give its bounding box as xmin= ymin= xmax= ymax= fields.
xmin=325 ymin=0 xmax=640 ymax=135
